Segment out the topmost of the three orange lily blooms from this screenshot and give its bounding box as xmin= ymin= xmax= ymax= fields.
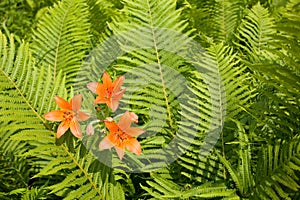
xmin=87 ymin=72 xmax=126 ymax=111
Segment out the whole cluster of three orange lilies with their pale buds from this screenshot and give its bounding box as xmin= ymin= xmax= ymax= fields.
xmin=45 ymin=72 xmax=146 ymax=160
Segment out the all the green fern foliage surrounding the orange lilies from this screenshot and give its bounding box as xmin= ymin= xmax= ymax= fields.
xmin=0 ymin=0 xmax=300 ymax=200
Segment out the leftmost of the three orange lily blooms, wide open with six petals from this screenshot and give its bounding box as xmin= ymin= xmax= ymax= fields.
xmin=45 ymin=94 xmax=90 ymax=138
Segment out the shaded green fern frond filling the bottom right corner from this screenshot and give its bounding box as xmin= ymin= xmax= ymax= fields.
xmin=252 ymin=135 xmax=300 ymax=199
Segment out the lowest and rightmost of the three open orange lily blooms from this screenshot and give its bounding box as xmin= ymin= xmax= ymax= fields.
xmin=99 ymin=111 xmax=146 ymax=160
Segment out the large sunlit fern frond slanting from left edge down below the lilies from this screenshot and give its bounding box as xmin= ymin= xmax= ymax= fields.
xmin=0 ymin=30 xmax=124 ymax=199
